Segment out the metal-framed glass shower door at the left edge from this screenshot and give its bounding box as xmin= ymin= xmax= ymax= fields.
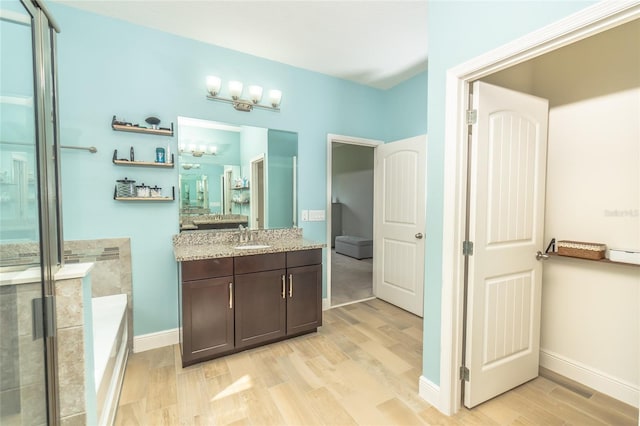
xmin=0 ymin=0 xmax=59 ymax=425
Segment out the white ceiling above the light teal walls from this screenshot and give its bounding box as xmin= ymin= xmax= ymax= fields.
xmin=51 ymin=0 xmax=427 ymax=89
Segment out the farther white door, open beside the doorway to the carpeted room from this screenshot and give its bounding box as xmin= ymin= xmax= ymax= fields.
xmin=374 ymin=135 xmax=427 ymax=316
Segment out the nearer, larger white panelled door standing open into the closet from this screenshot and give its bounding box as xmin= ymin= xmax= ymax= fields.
xmin=464 ymin=82 xmax=548 ymax=408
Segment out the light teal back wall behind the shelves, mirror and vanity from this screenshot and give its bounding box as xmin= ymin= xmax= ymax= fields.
xmin=49 ymin=3 xmax=416 ymax=335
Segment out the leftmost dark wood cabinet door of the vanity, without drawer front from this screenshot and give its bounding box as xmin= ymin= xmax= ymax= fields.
xmin=182 ymin=277 xmax=234 ymax=366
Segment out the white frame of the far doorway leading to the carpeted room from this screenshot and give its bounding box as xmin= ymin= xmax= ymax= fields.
xmin=322 ymin=133 xmax=384 ymax=311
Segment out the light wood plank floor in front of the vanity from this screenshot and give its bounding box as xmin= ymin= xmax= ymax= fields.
xmin=116 ymin=300 xmax=638 ymax=426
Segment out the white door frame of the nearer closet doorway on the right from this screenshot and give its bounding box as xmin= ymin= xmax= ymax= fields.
xmin=436 ymin=1 xmax=640 ymax=415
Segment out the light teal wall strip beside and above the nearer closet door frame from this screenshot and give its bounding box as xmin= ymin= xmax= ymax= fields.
xmin=423 ymin=1 xmax=594 ymax=384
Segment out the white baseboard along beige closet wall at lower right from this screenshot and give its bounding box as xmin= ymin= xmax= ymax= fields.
xmin=540 ymin=350 xmax=640 ymax=408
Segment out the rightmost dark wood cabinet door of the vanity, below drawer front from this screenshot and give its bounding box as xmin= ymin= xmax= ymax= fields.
xmin=287 ymin=265 xmax=322 ymax=335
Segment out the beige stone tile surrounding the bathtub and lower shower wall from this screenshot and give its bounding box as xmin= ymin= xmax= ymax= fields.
xmin=0 ymin=238 xmax=133 ymax=424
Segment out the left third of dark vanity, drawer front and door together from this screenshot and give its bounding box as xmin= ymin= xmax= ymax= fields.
xmin=180 ymin=258 xmax=235 ymax=366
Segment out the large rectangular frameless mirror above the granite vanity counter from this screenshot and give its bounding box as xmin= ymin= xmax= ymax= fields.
xmin=177 ymin=117 xmax=298 ymax=231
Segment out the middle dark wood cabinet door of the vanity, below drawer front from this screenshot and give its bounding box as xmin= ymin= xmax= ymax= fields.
xmin=235 ymin=269 xmax=286 ymax=348
